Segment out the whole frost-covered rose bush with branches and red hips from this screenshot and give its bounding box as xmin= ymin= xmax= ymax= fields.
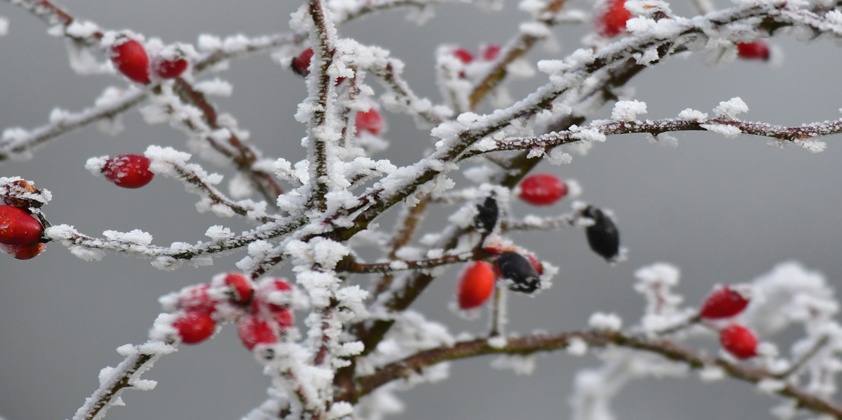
xmin=0 ymin=0 xmax=842 ymax=420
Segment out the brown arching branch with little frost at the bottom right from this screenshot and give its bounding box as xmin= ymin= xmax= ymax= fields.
xmin=352 ymin=331 xmax=842 ymax=419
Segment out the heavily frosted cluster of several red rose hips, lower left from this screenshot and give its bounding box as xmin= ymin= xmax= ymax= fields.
xmin=166 ymin=273 xmax=293 ymax=350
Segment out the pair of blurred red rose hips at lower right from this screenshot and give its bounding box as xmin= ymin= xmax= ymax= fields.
xmin=699 ymin=286 xmax=758 ymax=359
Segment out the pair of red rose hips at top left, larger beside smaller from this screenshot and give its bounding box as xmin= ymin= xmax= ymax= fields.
xmin=109 ymin=37 xmax=188 ymax=84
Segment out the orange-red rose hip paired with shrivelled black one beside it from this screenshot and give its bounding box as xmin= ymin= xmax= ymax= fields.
xmin=456 ymin=248 xmax=544 ymax=310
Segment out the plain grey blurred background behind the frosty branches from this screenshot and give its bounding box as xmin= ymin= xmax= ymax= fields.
xmin=0 ymin=0 xmax=842 ymax=420
